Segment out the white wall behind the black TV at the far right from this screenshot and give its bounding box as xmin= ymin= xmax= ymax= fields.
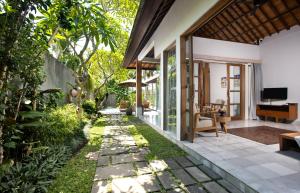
xmin=260 ymin=26 xmax=300 ymax=121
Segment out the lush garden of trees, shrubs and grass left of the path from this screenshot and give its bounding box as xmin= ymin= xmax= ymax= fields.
xmin=0 ymin=0 xmax=139 ymax=193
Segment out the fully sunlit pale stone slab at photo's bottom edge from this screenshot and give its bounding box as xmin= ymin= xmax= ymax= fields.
xmin=111 ymin=177 xmax=147 ymax=193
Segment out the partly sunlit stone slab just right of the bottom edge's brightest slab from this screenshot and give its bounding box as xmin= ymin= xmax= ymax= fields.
xmin=136 ymin=174 xmax=160 ymax=192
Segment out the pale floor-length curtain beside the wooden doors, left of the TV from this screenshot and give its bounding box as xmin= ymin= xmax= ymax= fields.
xmin=249 ymin=64 xmax=263 ymax=119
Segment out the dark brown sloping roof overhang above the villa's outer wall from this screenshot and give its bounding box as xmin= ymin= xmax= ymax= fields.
xmin=123 ymin=0 xmax=175 ymax=69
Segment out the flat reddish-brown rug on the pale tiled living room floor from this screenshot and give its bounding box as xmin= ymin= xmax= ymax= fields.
xmin=228 ymin=126 xmax=295 ymax=145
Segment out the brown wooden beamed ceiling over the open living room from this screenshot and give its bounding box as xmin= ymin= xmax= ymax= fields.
xmin=194 ymin=0 xmax=300 ymax=44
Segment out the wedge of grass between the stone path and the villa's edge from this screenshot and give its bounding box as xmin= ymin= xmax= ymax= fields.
xmin=128 ymin=117 xmax=186 ymax=160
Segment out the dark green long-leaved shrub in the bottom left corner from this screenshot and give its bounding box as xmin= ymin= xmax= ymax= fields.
xmin=0 ymin=146 xmax=71 ymax=193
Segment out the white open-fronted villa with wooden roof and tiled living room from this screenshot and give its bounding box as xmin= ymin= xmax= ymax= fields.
xmin=123 ymin=0 xmax=300 ymax=192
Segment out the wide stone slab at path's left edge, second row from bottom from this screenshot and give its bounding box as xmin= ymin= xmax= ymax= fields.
xmin=94 ymin=163 xmax=135 ymax=181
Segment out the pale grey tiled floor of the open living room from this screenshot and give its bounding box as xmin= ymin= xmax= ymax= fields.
xmin=183 ymin=121 xmax=300 ymax=193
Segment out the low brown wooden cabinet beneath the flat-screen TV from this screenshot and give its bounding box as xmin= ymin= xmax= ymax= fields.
xmin=256 ymin=103 xmax=298 ymax=122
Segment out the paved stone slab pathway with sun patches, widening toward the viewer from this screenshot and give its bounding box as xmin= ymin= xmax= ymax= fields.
xmin=92 ymin=126 xmax=239 ymax=193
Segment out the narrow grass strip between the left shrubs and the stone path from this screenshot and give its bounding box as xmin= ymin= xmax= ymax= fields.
xmin=49 ymin=118 xmax=105 ymax=193
